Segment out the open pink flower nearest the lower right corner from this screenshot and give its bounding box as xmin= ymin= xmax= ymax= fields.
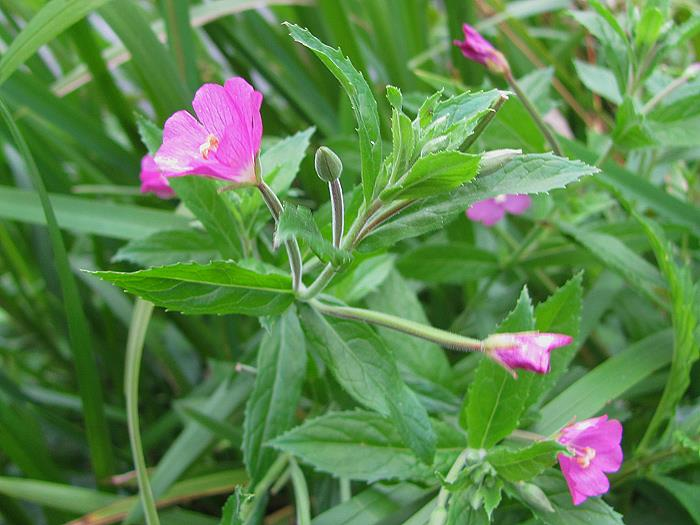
xmin=557 ymin=416 xmax=622 ymax=505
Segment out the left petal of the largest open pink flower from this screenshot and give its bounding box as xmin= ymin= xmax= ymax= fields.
xmin=155 ymin=111 xmax=208 ymax=176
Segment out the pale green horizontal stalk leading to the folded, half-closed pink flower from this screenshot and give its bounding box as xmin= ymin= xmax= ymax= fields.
xmin=310 ymin=299 xmax=482 ymax=351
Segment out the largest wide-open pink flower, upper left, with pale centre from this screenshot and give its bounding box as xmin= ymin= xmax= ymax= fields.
xmin=155 ymin=77 xmax=262 ymax=184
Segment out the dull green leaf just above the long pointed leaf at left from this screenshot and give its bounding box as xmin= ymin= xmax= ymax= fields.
xmin=112 ymin=230 xmax=218 ymax=266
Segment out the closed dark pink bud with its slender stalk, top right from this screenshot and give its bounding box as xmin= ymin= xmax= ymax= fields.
xmin=453 ymin=24 xmax=561 ymax=156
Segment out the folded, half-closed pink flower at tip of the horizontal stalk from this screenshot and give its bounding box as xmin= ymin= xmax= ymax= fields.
xmin=484 ymin=332 xmax=573 ymax=375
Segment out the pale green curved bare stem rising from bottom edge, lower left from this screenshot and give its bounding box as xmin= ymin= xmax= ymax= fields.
xmin=124 ymin=299 xmax=160 ymax=525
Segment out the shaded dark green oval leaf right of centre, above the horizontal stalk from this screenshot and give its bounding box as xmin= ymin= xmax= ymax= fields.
xmin=396 ymin=243 xmax=498 ymax=284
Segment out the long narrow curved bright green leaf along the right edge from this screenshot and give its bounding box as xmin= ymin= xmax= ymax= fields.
xmin=632 ymin=212 xmax=700 ymax=446
